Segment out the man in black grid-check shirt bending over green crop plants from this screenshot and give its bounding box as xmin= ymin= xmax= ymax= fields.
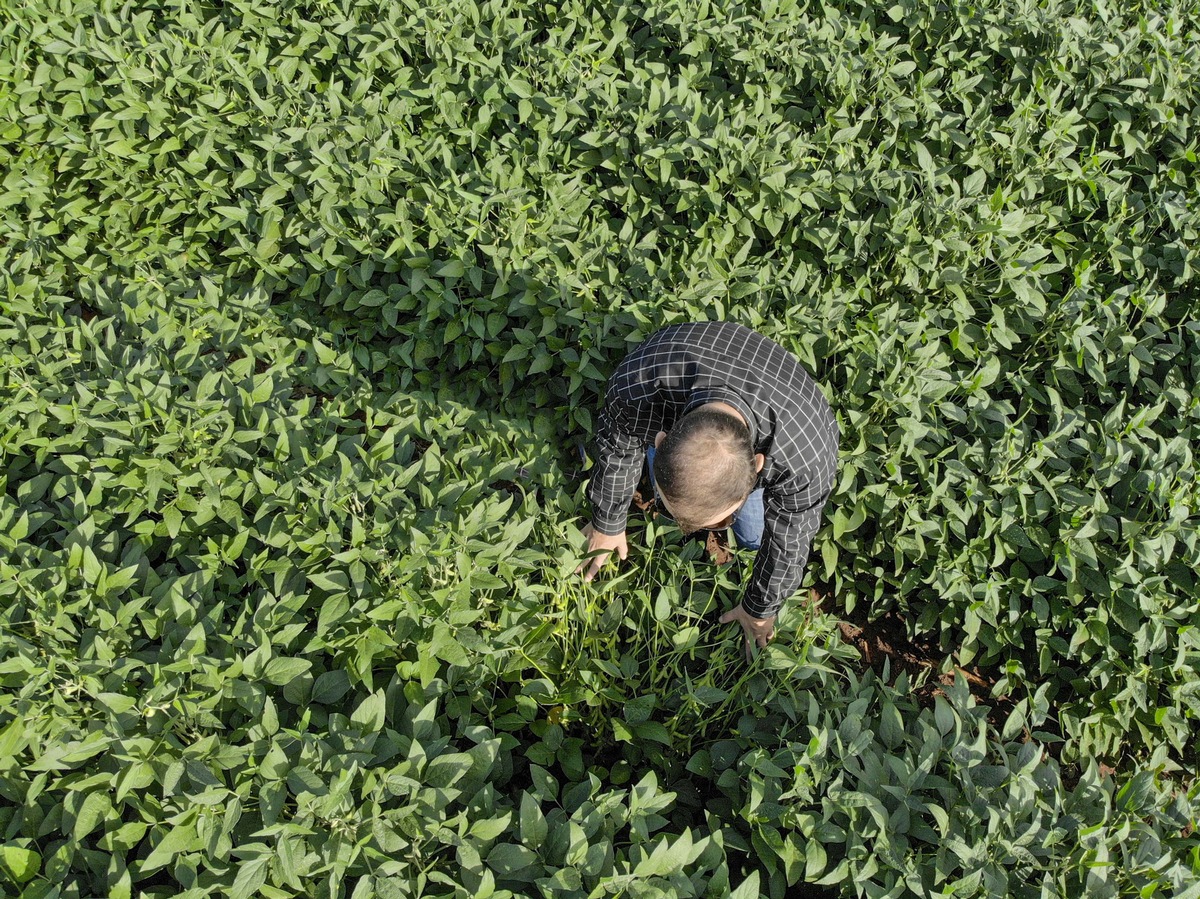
xmin=578 ymin=322 xmax=839 ymax=658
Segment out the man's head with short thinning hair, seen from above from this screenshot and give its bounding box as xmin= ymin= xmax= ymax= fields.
xmin=654 ymin=407 xmax=758 ymax=533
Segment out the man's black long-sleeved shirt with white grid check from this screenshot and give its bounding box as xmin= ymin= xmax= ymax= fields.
xmin=588 ymin=322 xmax=839 ymax=618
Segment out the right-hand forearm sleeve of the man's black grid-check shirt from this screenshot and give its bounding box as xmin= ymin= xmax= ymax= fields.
xmin=742 ymin=472 xmax=833 ymax=618
